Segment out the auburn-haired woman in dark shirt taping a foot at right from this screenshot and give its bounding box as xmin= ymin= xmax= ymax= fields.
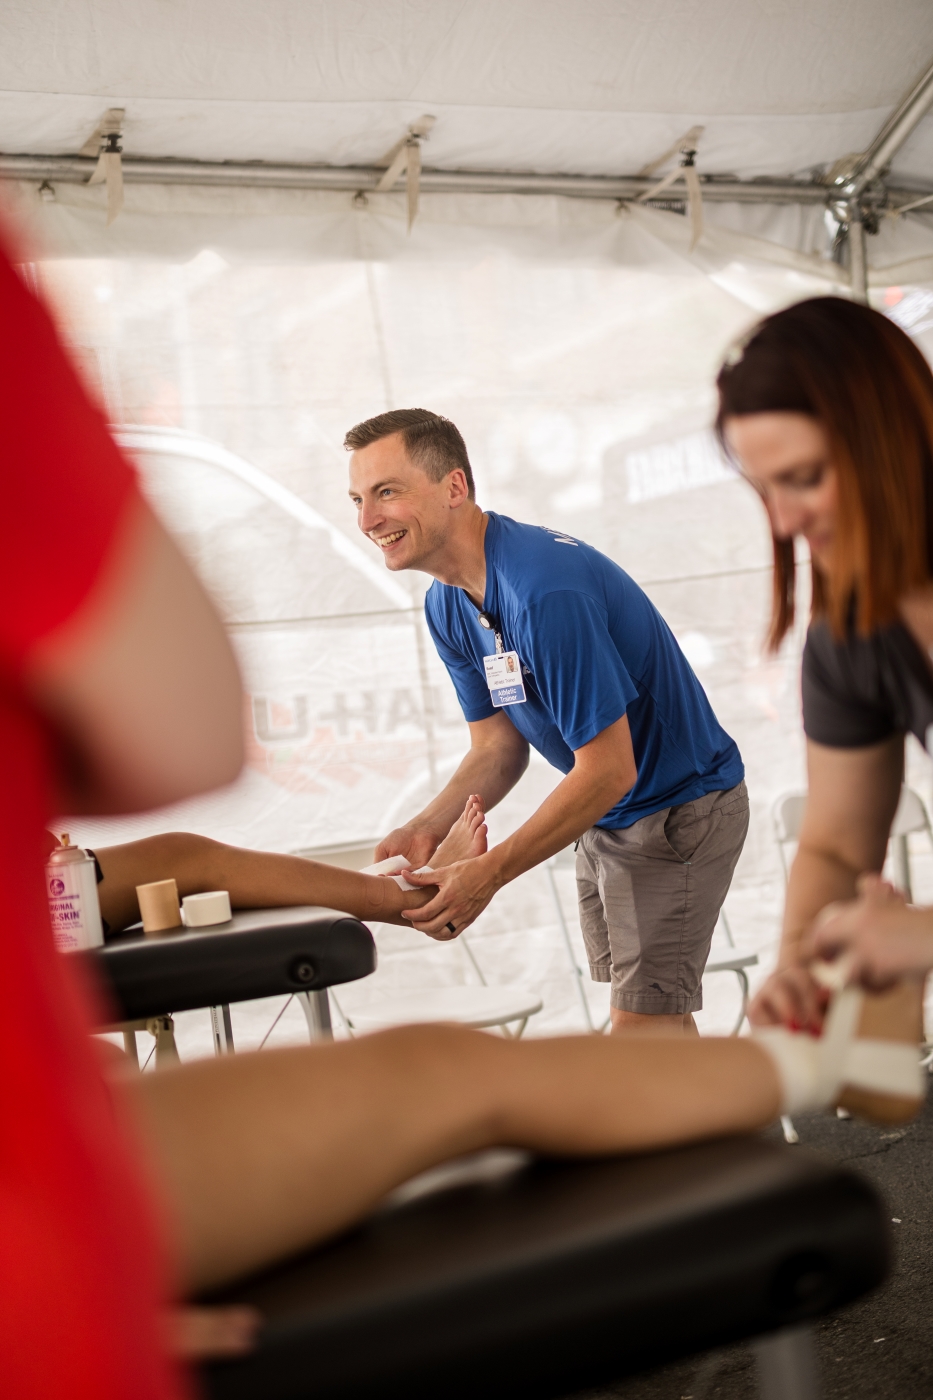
xmin=717 ymin=297 xmax=933 ymax=1026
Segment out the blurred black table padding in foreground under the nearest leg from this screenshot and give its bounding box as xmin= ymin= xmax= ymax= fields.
xmin=203 ymin=1138 xmax=888 ymax=1400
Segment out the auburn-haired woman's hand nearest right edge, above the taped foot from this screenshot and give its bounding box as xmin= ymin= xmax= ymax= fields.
xmin=801 ymin=875 xmax=933 ymax=991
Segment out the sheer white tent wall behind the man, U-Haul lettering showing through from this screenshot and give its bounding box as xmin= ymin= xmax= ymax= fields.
xmin=36 ymin=221 xmax=933 ymax=1030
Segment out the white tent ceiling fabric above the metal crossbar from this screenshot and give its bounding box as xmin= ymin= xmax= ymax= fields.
xmin=0 ymin=0 xmax=933 ymax=179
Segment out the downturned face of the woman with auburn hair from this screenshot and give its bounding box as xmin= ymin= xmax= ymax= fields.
xmin=724 ymin=413 xmax=839 ymax=574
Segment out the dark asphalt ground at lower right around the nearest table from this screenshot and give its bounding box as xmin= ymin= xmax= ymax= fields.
xmin=576 ymin=1096 xmax=933 ymax=1400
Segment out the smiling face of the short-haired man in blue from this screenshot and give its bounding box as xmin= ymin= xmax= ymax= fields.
xmin=350 ymin=433 xmax=469 ymax=574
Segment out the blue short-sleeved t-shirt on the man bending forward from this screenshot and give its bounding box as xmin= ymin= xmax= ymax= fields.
xmin=424 ymin=511 xmax=745 ymax=830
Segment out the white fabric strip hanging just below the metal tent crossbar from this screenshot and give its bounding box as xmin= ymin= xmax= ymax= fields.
xmin=9 ymin=177 xmax=933 ymax=278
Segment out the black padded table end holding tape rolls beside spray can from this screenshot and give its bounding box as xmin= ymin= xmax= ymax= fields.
xmin=71 ymin=906 xmax=375 ymax=1021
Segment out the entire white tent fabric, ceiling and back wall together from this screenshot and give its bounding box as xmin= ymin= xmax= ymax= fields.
xmin=0 ymin=0 xmax=933 ymax=1030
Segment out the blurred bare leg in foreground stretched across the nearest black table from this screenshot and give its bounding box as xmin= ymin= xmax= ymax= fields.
xmin=120 ymin=1026 xmax=780 ymax=1289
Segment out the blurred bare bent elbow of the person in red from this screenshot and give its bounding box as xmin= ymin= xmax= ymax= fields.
xmin=25 ymin=498 xmax=242 ymax=813
